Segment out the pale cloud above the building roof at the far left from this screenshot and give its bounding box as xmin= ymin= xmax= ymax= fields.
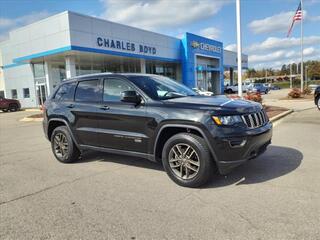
xmin=0 ymin=11 xmax=50 ymax=41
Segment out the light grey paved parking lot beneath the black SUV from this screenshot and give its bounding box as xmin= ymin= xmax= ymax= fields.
xmin=0 ymin=107 xmax=320 ymax=239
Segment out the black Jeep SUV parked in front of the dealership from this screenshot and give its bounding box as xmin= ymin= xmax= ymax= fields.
xmin=43 ymin=73 xmax=272 ymax=187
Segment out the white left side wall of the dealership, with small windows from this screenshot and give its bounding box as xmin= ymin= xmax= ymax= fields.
xmin=0 ymin=12 xmax=70 ymax=108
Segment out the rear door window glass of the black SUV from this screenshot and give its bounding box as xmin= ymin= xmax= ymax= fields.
xmin=75 ymin=79 xmax=101 ymax=102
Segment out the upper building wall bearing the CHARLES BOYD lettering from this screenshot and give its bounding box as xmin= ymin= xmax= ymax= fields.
xmin=69 ymin=12 xmax=180 ymax=59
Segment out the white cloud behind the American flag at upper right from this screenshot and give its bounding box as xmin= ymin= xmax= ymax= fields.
xmin=248 ymin=10 xmax=320 ymax=34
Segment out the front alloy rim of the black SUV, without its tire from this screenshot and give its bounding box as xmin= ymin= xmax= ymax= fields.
xmin=169 ymin=143 xmax=200 ymax=180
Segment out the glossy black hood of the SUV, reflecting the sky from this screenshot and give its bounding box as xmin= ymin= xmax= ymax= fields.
xmin=165 ymin=95 xmax=262 ymax=113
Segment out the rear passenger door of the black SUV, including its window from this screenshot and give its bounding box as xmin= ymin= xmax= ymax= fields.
xmin=72 ymin=78 xmax=102 ymax=146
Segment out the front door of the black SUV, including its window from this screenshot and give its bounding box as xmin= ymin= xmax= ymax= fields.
xmin=99 ymin=77 xmax=149 ymax=153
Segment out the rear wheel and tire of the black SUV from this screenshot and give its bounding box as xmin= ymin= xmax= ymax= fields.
xmin=51 ymin=126 xmax=80 ymax=163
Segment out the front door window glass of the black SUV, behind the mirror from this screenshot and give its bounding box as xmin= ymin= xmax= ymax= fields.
xmin=103 ymin=78 xmax=134 ymax=101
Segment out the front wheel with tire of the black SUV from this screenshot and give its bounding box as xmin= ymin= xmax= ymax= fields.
xmin=162 ymin=133 xmax=214 ymax=188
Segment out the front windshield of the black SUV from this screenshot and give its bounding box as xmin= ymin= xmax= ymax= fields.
xmin=129 ymin=76 xmax=198 ymax=100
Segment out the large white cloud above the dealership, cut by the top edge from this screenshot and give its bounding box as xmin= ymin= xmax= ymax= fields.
xmin=100 ymin=0 xmax=229 ymax=30
